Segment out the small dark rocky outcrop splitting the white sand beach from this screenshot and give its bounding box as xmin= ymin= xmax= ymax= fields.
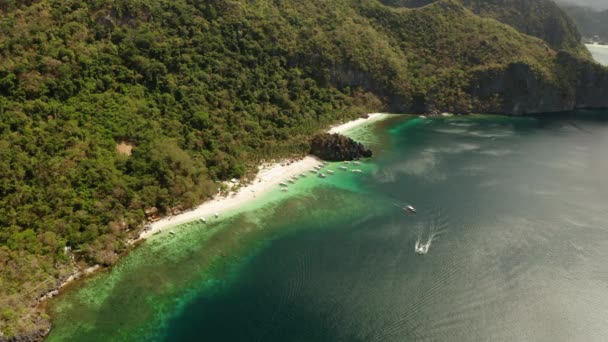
xmin=310 ymin=133 xmax=372 ymax=161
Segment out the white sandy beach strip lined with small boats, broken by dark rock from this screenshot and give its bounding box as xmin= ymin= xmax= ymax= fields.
xmin=133 ymin=113 xmax=387 ymax=242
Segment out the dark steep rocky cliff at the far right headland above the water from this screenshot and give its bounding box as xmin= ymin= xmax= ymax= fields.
xmin=467 ymin=52 xmax=608 ymax=115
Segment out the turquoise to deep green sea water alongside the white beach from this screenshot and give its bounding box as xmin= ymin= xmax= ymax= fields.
xmin=49 ymin=112 xmax=608 ymax=341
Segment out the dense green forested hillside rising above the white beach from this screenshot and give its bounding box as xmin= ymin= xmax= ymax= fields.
xmin=0 ymin=0 xmax=608 ymax=340
